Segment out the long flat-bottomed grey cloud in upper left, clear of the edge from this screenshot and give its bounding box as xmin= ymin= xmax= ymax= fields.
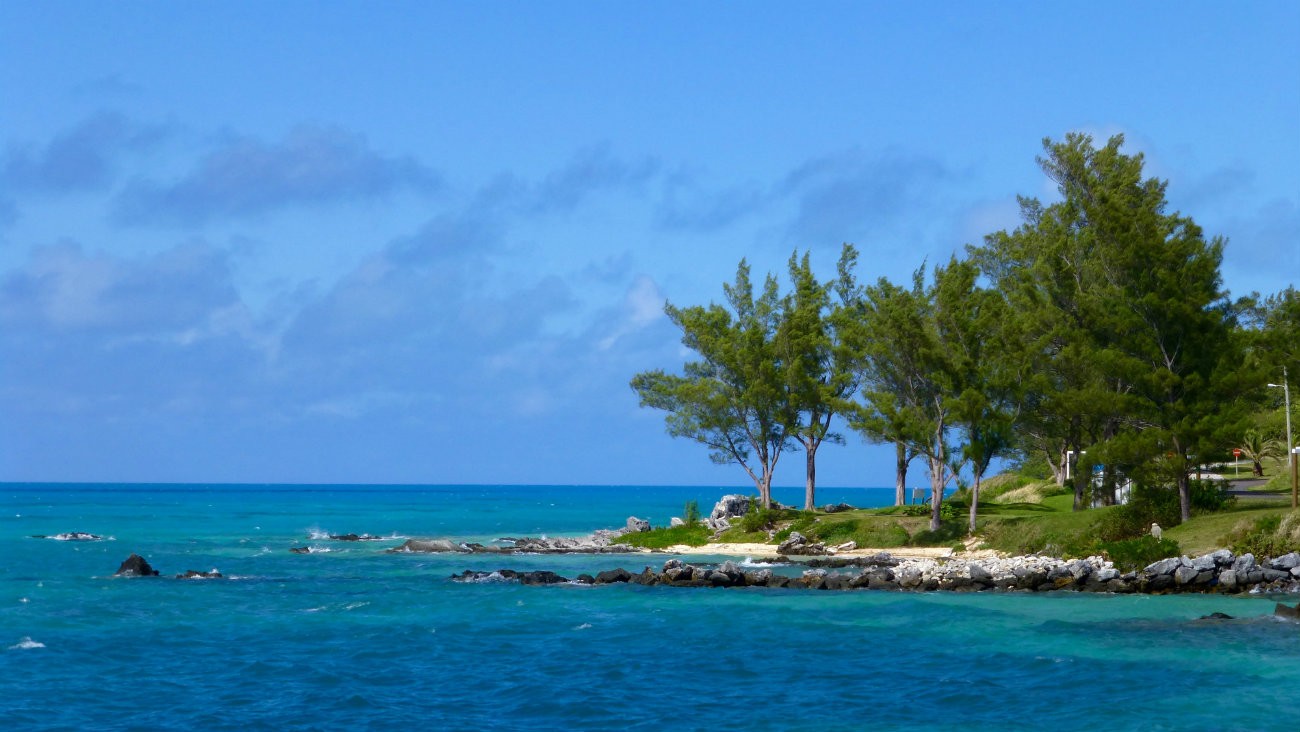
xmin=114 ymin=126 xmax=438 ymax=224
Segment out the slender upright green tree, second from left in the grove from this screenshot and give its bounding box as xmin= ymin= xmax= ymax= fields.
xmin=776 ymin=244 xmax=857 ymax=511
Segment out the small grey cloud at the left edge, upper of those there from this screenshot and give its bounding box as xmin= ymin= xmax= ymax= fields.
xmin=0 ymin=112 xmax=164 ymax=192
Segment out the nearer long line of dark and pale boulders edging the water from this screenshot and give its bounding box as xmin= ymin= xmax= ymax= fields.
xmin=451 ymin=549 xmax=1300 ymax=594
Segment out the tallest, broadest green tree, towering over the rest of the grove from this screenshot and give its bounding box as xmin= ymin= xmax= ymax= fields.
xmin=975 ymin=134 xmax=1243 ymax=520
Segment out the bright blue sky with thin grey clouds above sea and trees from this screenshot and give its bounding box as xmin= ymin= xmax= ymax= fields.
xmin=0 ymin=0 xmax=1300 ymax=489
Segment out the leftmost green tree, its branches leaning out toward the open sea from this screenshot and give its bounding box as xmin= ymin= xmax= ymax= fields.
xmin=632 ymin=260 xmax=796 ymax=507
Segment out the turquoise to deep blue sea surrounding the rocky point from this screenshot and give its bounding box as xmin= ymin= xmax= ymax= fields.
xmin=0 ymin=484 xmax=1300 ymax=731
